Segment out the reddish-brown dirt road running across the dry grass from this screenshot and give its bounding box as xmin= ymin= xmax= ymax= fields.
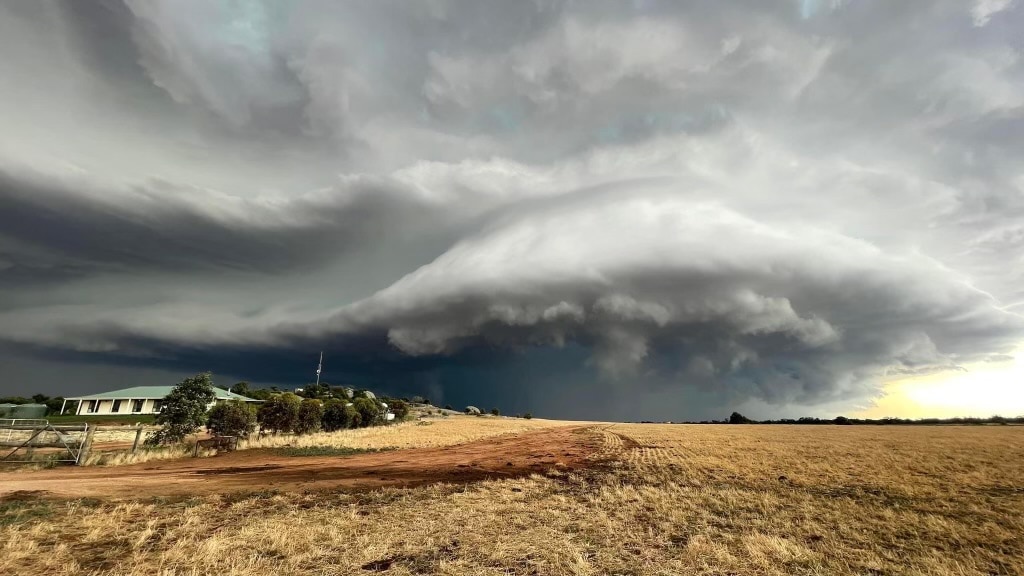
xmin=0 ymin=426 xmax=600 ymax=499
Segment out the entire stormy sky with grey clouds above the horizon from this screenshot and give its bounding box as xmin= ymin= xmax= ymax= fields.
xmin=0 ymin=0 xmax=1024 ymax=420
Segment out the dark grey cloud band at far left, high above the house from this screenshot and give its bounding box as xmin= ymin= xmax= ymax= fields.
xmin=0 ymin=163 xmax=440 ymax=279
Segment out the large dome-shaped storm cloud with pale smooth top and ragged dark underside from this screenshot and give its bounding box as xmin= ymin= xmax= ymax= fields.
xmin=280 ymin=190 xmax=1024 ymax=403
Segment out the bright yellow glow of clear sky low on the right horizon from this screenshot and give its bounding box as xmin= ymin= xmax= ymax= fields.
xmin=857 ymin=354 xmax=1024 ymax=418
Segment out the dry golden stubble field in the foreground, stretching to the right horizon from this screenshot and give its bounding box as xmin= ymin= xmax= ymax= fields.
xmin=0 ymin=418 xmax=1024 ymax=576
